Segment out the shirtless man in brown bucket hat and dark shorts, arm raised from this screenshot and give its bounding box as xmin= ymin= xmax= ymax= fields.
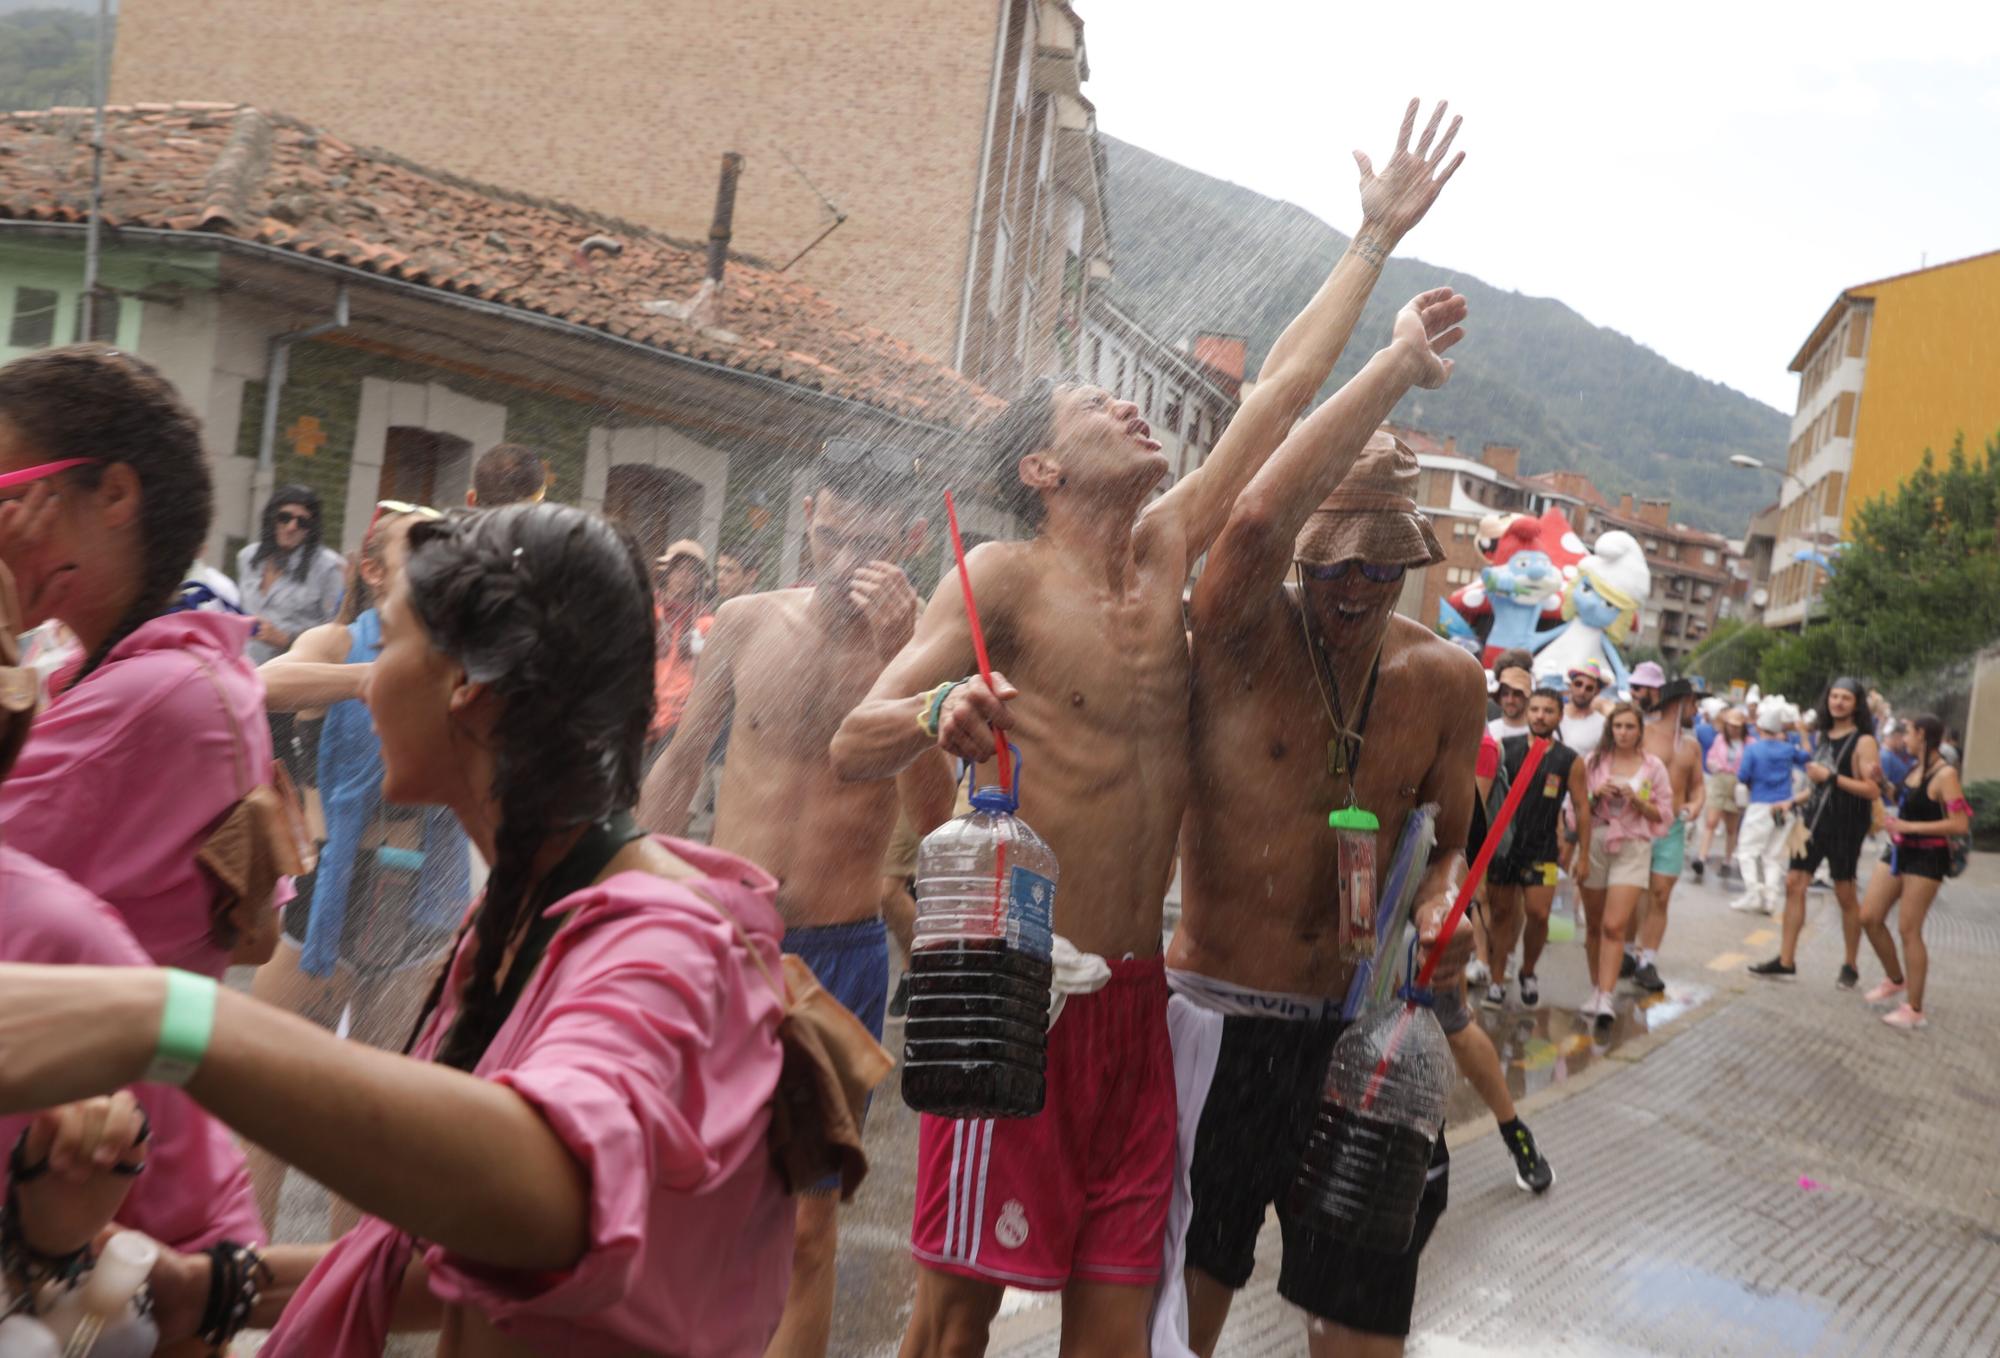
xmin=1154 ymin=318 xmax=1486 ymax=1356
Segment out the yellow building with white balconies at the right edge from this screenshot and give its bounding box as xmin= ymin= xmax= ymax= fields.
xmin=1764 ymin=250 xmax=2000 ymax=626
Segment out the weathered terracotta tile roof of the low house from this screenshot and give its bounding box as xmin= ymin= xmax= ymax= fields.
xmin=0 ymin=102 xmax=1000 ymax=426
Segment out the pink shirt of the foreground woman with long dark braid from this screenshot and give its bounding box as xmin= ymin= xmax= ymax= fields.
xmin=262 ymin=840 xmax=794 ymax=1358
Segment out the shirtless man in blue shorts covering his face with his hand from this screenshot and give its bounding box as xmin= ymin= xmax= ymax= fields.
xmin=638 ymin=438 xmax=952 ymax=1358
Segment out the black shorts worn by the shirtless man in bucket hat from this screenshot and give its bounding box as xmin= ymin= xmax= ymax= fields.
xmin=1188 ymin=1016 xmax=1450 ymax=1336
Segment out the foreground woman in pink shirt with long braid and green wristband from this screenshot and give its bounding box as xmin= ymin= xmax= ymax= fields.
xmin=0 ymin=504 xmax=794 ymax=1358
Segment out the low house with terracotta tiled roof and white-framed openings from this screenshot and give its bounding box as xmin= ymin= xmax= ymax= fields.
xmin=0 ymin=104 xmax=1008 ymax=584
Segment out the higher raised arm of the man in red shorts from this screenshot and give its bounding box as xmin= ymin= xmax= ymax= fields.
xmin=1150 ymin=100 xmax=1466 ymax=566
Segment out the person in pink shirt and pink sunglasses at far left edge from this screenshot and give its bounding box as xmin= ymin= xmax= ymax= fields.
xmin=0 ymin=344 xmax=278 ymax=976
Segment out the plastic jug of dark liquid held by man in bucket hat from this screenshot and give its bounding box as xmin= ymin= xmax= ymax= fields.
xmin=1292 ymin=996 xmax=1454 ymax=1252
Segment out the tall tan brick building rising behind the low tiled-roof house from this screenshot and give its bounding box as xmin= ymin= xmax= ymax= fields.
xmin=112 ymin=0 xmax=1110 ymax=402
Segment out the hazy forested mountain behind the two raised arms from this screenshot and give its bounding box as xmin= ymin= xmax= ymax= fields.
xmin=1104 ymin=136 xmax=1790 ymax=536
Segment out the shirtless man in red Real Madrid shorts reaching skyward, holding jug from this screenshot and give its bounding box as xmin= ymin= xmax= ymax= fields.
xmin=834 ymin=102 xmax=1458 ymax=1358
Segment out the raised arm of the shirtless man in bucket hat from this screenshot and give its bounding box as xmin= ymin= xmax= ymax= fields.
xmin=1194 ymin=288 xmax=1466 ymax=628
